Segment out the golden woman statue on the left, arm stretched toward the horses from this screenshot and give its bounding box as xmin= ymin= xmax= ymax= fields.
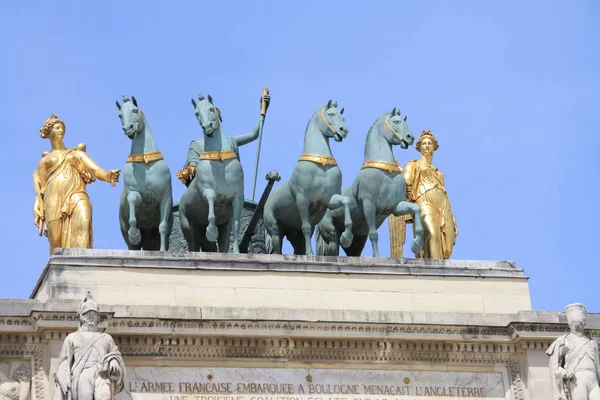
xmin=33 ymin=114 xmax=120 ymax=255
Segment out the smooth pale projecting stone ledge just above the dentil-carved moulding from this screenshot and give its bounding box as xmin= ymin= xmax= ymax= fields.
xmin=0 ymin=299 xmax=600 ymax=332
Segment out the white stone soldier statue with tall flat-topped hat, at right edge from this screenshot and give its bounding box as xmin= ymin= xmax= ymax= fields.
xmin=546 ymin=303 xmax=600 ymax=400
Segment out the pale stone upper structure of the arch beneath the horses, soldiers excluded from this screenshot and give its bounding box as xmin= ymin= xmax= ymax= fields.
xmin=0 ymin=249 xmax=600 ymax=400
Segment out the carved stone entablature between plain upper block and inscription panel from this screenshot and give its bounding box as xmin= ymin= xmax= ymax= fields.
xmin=0 ymin=300 xmax=600 ymax=399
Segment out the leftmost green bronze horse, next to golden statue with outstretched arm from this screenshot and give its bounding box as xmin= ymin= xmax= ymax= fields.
xmin=116 ymin=96 xmax=173 ymax=251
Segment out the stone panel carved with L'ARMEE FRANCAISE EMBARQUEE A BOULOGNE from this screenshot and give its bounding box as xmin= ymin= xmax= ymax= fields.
xmin=117 ymin=367 xmax=506 ymax=400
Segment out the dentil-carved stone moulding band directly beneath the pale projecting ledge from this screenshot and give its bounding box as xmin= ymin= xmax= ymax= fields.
xmin=0 ymin=311 xmax=600 ymax=343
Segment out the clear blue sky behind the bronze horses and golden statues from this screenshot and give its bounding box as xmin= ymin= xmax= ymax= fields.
xmin=0 ymin=0 xmax=600 ymax=312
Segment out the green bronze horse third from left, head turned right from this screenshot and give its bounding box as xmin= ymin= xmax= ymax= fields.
xmin=263 ymin=100 xmax=352 ymax=255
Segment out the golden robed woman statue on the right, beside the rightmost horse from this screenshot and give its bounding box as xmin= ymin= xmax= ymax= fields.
xmin=403 ymin=131 xmax=458 ymax=259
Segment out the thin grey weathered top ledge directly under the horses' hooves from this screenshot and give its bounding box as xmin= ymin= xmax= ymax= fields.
xmin=39 ymin=249 xmax=525 ymax=278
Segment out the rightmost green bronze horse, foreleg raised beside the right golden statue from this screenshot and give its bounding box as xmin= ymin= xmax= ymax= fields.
xmin=317 ymin=108 xmax=423 ymax=257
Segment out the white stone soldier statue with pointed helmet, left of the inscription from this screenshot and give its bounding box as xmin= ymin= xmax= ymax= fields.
xmin=53 ymin=292 xmax=125 ymax=400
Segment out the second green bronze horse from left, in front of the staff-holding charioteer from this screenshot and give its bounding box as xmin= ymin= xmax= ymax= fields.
xmin=179 ymin=95 xmax=252 ymax=253
